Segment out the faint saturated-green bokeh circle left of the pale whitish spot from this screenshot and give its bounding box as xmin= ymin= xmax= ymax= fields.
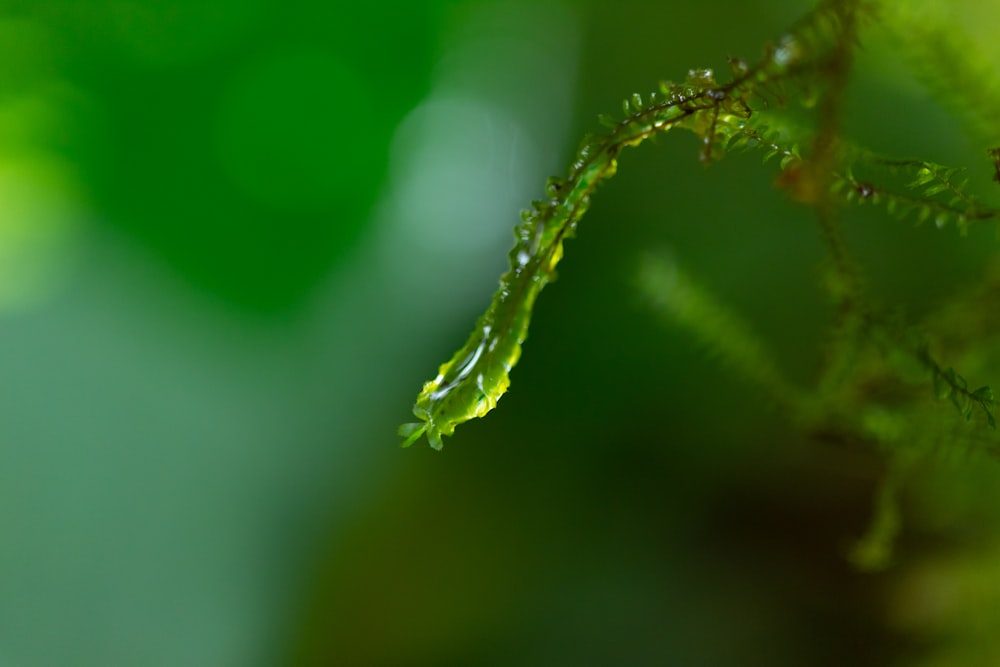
xmin=216 ymin=50 xmax=382 ymax=209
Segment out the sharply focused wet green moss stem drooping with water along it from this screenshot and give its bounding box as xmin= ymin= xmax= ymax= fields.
xmin=399 ymin=4 xmax=864 ymax=449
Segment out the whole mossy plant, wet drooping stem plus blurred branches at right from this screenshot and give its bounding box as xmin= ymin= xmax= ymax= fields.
xmin=400 ymin=0 xmax=1000 ymax=512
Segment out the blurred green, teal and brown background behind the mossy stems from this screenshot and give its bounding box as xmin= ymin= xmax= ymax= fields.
xmin=0 ymin=0 xmax=995 ymax=667
